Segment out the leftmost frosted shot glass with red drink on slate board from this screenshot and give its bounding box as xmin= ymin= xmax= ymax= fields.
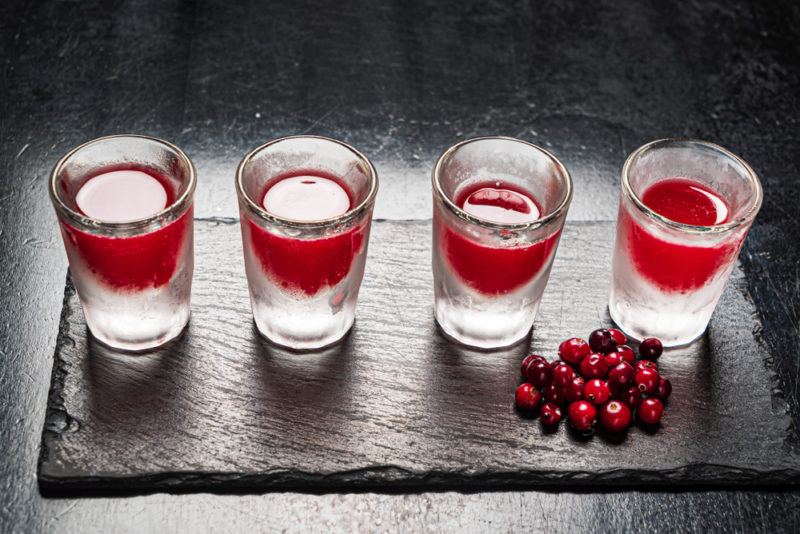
xmin=50 ymin=135 xmax=196 ymax=351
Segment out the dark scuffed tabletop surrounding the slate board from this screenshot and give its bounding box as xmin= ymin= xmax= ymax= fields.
xmin=0 ymin=0 xmax=800 ymax=532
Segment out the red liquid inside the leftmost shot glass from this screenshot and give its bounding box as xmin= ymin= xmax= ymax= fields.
xmin=61 ymin=169 xmax=192 ymax=291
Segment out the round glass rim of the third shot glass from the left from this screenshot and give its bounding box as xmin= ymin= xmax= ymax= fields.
xmin=431 ymin=135 xmax=573 ymax=230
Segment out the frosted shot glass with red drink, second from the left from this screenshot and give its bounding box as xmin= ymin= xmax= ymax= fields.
xmin=236 ymin=136 xmax=378 ymax=350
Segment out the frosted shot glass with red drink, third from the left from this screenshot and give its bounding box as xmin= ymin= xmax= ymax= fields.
xmin=433 ymin=137 xmax=572 ymax=349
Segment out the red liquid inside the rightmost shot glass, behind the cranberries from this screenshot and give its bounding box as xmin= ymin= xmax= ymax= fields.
xmin=619 ymin=178 xmax=741 ymax=292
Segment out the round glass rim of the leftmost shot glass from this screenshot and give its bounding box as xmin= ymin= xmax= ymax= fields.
xmin=50 ymin=134 xmax=197 ymax=231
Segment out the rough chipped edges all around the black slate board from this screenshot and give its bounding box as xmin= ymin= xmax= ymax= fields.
xmin=37 ymin=217 xmax=800 ymax=494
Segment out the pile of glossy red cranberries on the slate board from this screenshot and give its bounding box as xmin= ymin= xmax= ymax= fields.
xmin=515 ymin=328 xmax=672 ymax=432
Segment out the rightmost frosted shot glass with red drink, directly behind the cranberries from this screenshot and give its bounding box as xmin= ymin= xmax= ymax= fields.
xmin=608 ymin=139 xmax=762 ymax=346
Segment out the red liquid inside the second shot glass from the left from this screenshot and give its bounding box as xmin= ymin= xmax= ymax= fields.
xmin=249 ymin=171 xmax=365 ymax=296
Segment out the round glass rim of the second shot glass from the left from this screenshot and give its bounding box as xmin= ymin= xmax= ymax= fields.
xmin=236 ymin=135 xmax=378 ymax=229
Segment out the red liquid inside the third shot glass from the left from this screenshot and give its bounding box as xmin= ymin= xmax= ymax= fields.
xmin=440 ymin=182 xmax=560 ymax=295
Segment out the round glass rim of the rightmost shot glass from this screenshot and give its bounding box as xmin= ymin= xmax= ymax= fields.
xmin=621 ymin=137 xmax=764 ymax=234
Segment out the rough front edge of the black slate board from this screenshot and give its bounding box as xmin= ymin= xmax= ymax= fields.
xmin=39 ymin=463 xmax=800 ymax=496
